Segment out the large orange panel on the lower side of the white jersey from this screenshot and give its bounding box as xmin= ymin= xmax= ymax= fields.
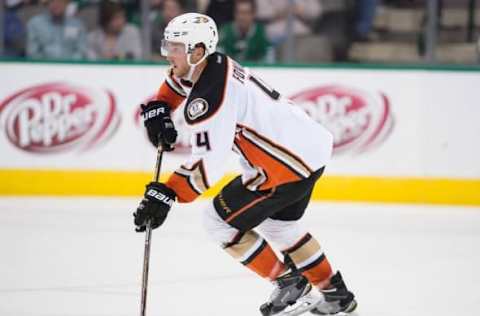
xmin=235 ymin=134 xmax=302 ymax=190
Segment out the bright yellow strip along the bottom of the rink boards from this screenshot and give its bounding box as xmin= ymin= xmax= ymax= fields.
xmin=0 ymin=169 xmax=480 ymax=206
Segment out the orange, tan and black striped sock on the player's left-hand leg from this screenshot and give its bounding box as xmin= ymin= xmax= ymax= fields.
xmin=225 ymin=231 xmax=285 ymax=280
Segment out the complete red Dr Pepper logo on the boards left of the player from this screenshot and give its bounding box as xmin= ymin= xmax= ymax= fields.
xmin=0 ymin=82 xmax=120 ymax=153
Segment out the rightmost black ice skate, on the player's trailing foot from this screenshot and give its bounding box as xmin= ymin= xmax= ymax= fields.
xmin=310 ymin=271 xmax=357 ymax=315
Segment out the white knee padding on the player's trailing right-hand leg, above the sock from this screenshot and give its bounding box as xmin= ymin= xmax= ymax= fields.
xmin=256 ymin=218 xmax=307 ymax=250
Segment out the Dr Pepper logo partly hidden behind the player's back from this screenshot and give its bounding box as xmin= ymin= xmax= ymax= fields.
xmin=291 ymin=85 xmax=393 ymax=153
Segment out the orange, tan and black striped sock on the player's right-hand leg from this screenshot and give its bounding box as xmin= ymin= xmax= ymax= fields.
xmin=282 ymin=233 xmax=332 ymax=288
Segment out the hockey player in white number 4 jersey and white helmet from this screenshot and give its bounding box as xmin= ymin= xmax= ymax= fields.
xmin=134 ymin=13 xmax=357 ymax=316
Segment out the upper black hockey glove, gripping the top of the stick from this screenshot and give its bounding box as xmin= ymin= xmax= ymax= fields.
xmin=141 ymin=101 xmax=177 ymax=151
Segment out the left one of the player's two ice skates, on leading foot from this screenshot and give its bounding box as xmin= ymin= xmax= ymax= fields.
xmin=260 ymin=271 xmax=323 ymax=316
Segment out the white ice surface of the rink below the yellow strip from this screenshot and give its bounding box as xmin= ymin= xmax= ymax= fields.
xmin=0 ymin=197 xmax=480 ymax=316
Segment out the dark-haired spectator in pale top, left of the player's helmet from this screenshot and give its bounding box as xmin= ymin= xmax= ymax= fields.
xmin=88 ymin=0 xmax=142 ymax=60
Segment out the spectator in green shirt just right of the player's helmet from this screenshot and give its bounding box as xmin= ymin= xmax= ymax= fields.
xmin=220 ymin=0 xmax=269 ymax=62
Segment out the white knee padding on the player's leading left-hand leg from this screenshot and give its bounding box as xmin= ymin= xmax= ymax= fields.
xmin=203 ymin=202 xmax=239 ymax=245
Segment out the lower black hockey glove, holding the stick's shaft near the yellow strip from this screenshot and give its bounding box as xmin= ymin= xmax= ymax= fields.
xmin=133 ymin=182 xmax=176 ymax=232
